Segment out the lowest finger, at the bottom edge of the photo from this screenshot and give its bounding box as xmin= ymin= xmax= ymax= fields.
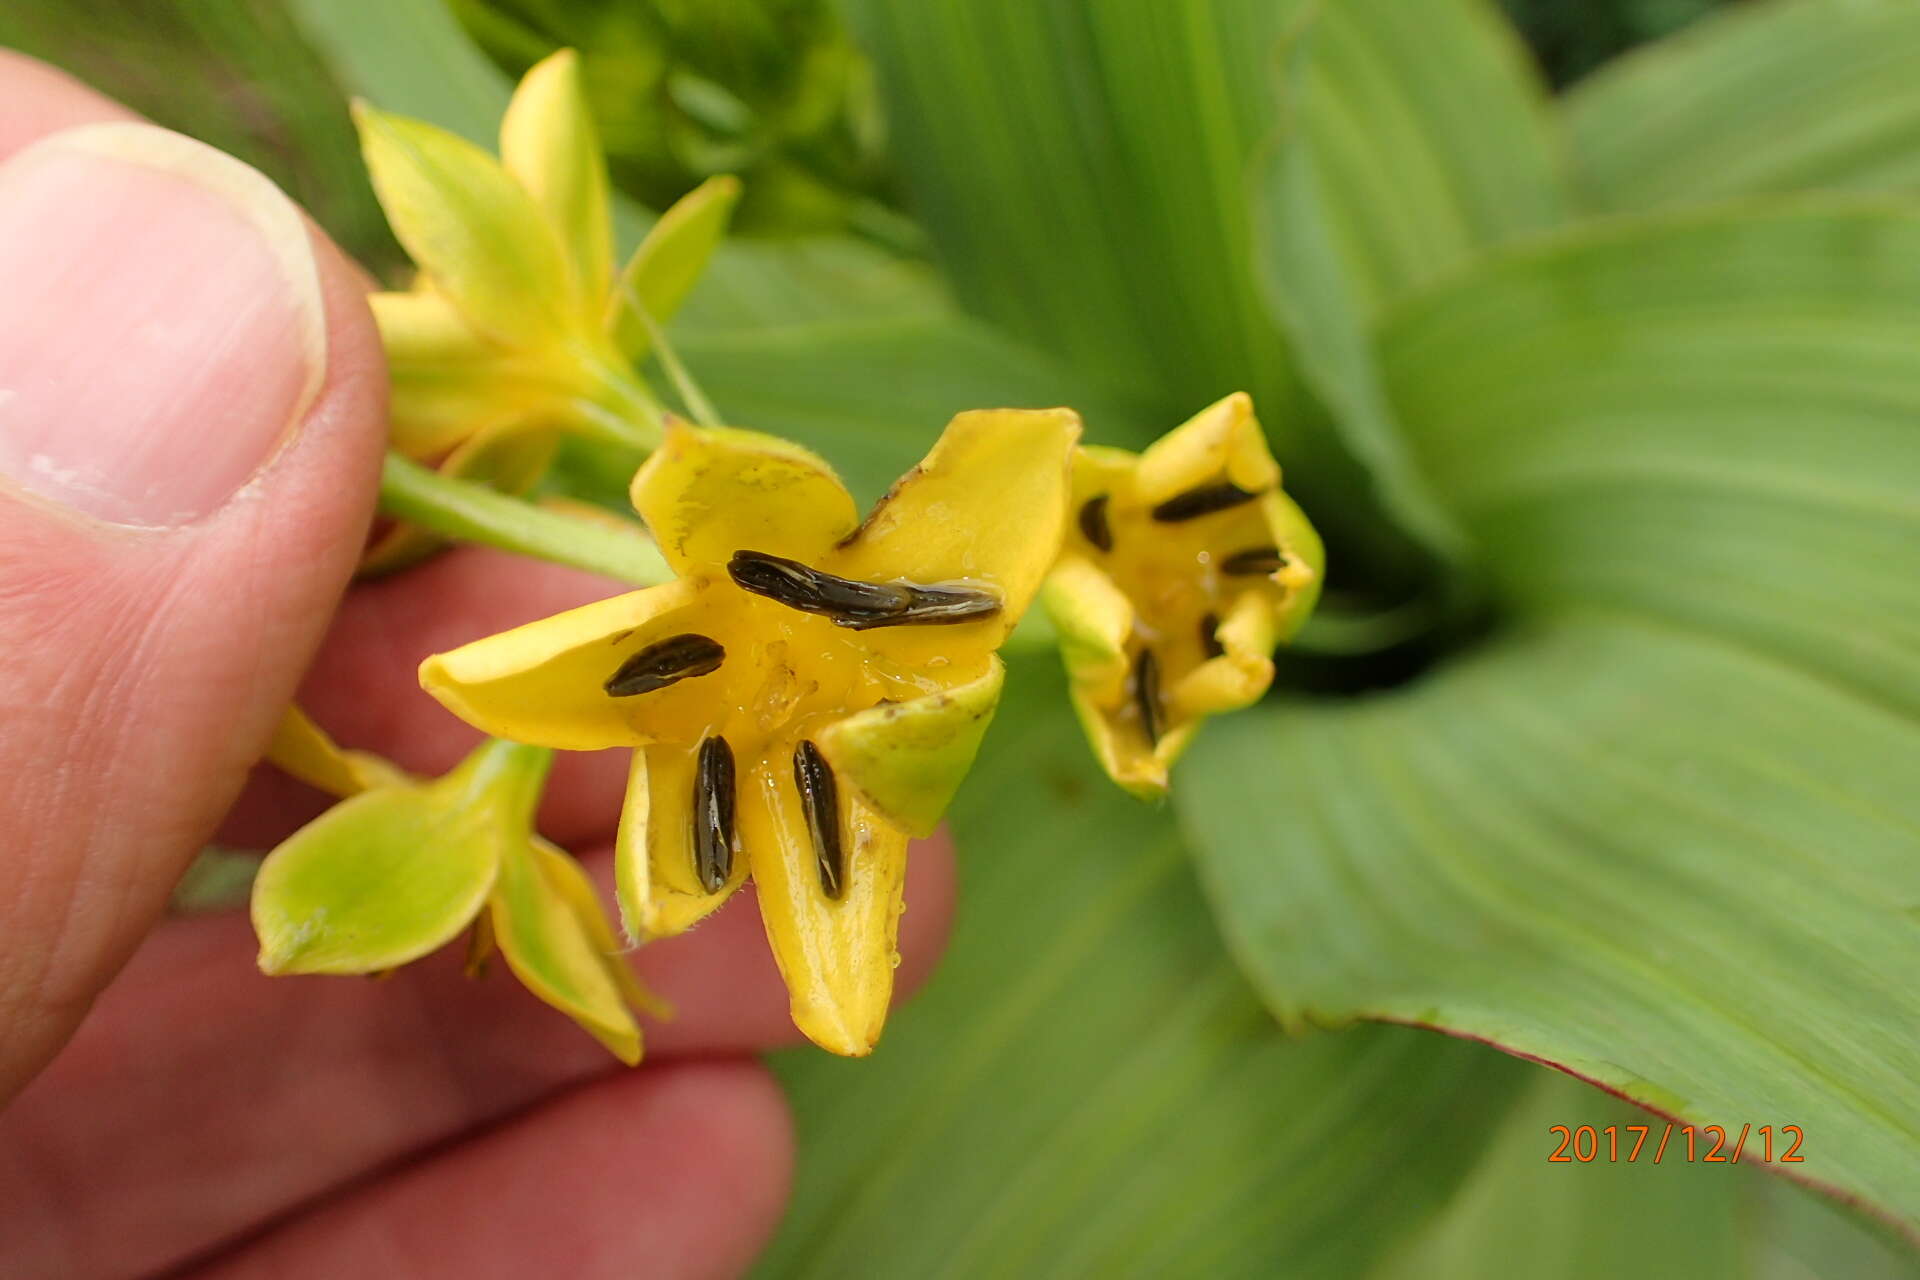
xmin=198 ymin=1063 xmax=793 ymax=1280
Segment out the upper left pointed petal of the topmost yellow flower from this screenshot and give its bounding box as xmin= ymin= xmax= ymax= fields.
xmin=353 ymin=104 xmax=580 ymax=347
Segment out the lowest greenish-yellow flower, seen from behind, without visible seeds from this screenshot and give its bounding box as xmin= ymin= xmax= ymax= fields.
xmin=253 ymin=708 xmax=660 ymax=1065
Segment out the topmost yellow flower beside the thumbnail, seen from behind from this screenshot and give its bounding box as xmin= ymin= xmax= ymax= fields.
xmin=353 ymin=50 xmax=739 ymax=568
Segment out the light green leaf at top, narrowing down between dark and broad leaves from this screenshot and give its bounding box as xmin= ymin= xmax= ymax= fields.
xmin=1254 ymin=0 xmax=1572 ymax=553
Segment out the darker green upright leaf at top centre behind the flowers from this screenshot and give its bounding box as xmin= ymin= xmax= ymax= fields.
xmin=852 ymin=0 xmax=1300 ymax=429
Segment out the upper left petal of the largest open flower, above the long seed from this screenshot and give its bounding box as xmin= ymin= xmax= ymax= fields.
xmin=634 ymin=422 xmax=860 ymax=574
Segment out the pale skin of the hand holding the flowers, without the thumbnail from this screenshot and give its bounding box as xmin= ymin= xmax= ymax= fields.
xmin=0 ymin=50 xmax=952 ymax=1280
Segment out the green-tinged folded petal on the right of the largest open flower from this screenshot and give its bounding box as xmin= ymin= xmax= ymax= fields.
xmin=814 ymin=656 xmax=1006 ymax=837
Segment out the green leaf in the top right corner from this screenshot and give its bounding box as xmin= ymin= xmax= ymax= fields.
xmin=1565 ymin=0 xmax=1920 ymax=209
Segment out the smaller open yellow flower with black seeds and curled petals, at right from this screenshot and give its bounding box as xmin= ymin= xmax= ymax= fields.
xmin=1044 ymin=391 xmax=1325 ymax=796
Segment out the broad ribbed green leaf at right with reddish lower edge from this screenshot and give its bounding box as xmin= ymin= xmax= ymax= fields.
xmin=1175 ymin=205 xmax=1920 ymax=1228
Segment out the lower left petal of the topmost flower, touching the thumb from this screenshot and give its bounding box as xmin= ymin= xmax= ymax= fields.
xmin=367 ymin=292 xmax=572 ymax=461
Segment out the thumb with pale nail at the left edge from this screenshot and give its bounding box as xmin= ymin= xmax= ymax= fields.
xmin=0 ymin=123 xmax=384 ymax=1102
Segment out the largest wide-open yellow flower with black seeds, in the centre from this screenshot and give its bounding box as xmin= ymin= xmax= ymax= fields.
xmin=420 ymin=409 xmax=1079 ymax=1054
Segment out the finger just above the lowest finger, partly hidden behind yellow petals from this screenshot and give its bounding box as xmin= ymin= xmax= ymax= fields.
xmin=0 ymin=841 xmax=954 ymax=1276
